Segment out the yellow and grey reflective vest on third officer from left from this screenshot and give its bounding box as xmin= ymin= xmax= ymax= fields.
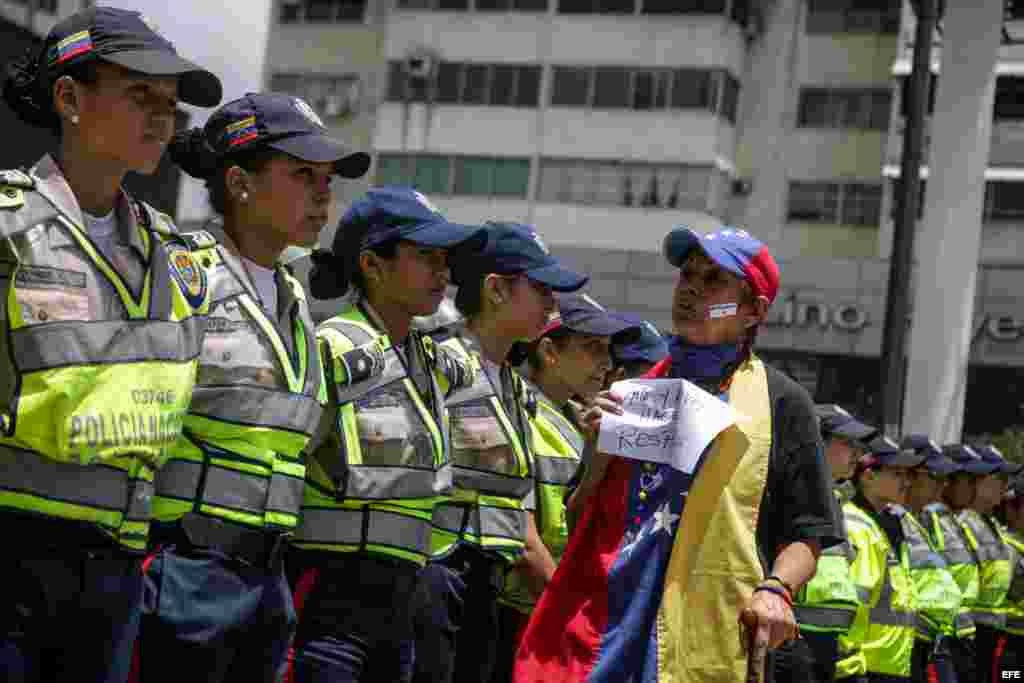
xmin=294 ymin=302 xmax=472 ymax=565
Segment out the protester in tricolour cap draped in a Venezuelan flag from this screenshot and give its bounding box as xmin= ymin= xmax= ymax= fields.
xmin=515 ymin=227 xmax=842 ymax=683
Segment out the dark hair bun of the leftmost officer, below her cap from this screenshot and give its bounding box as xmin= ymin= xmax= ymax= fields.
xmin=2 ymin=45 xmax=97 ymax=135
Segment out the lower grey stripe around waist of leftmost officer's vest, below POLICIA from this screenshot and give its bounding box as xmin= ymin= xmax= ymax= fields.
xmin=0 ymin=446 xmax=153 ymax=521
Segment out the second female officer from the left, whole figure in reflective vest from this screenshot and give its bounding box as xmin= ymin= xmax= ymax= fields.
xmin=134 ymin=94 xmax=370 ymax=681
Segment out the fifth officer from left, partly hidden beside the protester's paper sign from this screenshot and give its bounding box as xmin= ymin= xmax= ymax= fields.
xmin=490 ymin=294 xmax=640 ymax=683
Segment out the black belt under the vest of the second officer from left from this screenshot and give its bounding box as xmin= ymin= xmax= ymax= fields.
xmin=174 ymin=512 xmax=292 ymax=570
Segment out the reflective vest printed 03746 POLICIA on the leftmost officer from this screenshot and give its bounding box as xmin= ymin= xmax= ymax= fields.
xmin=0 ymin=157 xmax=208 ymax=551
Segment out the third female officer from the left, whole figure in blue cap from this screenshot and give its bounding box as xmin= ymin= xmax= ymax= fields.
xmin=284 ymin=187 xmax=483 ymax=683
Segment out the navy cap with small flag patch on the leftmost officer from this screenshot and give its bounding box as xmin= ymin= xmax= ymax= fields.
xmin=40 ymin=7 xmax=223 ymax=106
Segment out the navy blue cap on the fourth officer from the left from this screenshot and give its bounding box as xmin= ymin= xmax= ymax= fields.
xmin=452 ymin=222 xmax=590 ymax=292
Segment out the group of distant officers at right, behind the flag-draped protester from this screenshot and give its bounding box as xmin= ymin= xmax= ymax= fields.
xmin=786 ymin=405 xmax=1024 ymax=682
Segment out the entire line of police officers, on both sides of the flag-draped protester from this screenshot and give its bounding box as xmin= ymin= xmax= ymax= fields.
xmin=0 ymin=7 xmax=1024 ymax=683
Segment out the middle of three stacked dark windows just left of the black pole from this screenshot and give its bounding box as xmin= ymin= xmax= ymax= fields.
xmin=797 ymin=88 xmax=892 ymax=130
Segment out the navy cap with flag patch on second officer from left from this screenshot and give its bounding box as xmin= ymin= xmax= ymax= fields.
xmin=203 ymin=92 xmax=370 ymax=178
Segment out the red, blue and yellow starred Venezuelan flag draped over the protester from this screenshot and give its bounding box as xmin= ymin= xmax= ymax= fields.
xmin=514 ymin=356 xmax=771 ymax=683
